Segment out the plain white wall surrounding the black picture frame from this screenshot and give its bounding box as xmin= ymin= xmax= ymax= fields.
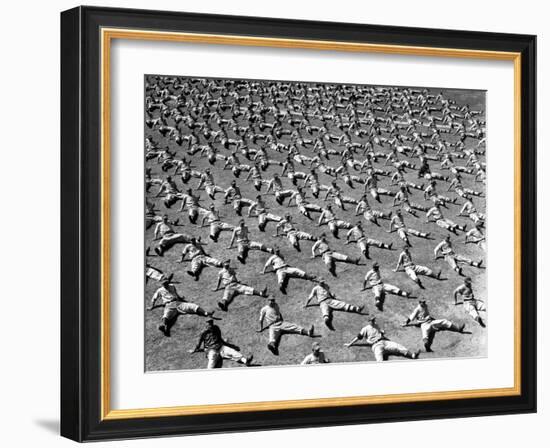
xmin=0 ymin=0 xmax=550 ymax=448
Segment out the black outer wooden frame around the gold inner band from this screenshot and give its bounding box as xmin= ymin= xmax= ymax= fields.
xmin=61 ymin=7 xmax=537 ymax=441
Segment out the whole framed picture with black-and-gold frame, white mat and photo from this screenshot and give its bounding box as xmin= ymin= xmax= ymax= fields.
xmin=61 ymin=7 xmax=536 ymax=441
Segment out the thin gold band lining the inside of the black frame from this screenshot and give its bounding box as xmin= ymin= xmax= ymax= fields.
xmin=100 ymin=28 xmax=521 ymax=420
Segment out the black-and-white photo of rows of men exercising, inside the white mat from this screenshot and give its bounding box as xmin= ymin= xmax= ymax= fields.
xmin=144 ymin=75 xmax=489 ymax=371
